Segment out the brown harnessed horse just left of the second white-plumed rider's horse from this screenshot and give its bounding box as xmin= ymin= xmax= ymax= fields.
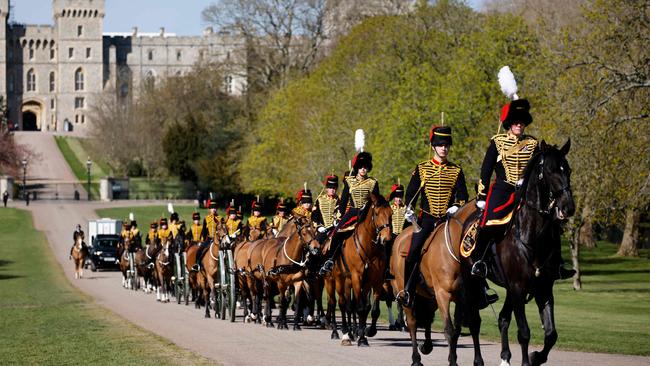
xmin=247 ymin=217 xmax=320 ymax=330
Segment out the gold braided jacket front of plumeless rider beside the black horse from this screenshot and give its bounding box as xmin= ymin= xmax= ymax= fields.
xmin=418 ymin=160 xmax=464 ymax=217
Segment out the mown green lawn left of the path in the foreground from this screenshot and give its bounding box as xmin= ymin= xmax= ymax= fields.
xmin=0 ymin=208 xmax=214 ymax=365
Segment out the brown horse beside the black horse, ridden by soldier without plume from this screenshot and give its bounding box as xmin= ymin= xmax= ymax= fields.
xmin=390 ymin=201 xmax=483 ymax=366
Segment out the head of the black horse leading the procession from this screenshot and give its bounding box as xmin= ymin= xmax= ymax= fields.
xmin=529 ymin=139 xmax=575 ymax=220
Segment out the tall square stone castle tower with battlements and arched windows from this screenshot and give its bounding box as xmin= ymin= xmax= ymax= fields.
xmin=52 ymin=0 xmax=105 ymax=130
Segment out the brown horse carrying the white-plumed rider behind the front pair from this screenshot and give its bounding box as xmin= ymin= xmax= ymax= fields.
xmin=325 ymin=194 xmax=392 ymax=346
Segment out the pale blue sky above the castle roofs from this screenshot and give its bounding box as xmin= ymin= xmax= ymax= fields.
xmin=10 ymin=0 xmax=482 ymax=36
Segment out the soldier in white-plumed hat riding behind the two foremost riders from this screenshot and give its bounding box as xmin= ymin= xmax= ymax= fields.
xmin=320 ymin=130 xmax=379 ymax=274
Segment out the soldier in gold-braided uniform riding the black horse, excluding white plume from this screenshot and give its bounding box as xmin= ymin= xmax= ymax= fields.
xmin=471 ymin=94 xmax=575 ymax=279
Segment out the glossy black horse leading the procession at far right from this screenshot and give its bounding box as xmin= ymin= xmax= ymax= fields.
xmin=470 ymin=140 xmax=575 ymax=366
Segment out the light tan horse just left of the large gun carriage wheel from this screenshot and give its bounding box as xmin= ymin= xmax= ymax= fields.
xmin=195 ymin=222 xmax=228 ymax=318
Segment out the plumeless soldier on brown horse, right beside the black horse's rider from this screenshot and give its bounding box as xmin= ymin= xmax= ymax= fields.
xmin=398 ymin=126 xmax=468 ymax=307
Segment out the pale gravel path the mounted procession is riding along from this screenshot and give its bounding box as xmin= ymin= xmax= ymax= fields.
xmin=15 ymin=133 xmax=650 ymax=366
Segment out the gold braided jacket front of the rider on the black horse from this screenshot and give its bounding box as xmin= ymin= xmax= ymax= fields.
xmin=492 ymin=134 xmax=537 ymax=186
